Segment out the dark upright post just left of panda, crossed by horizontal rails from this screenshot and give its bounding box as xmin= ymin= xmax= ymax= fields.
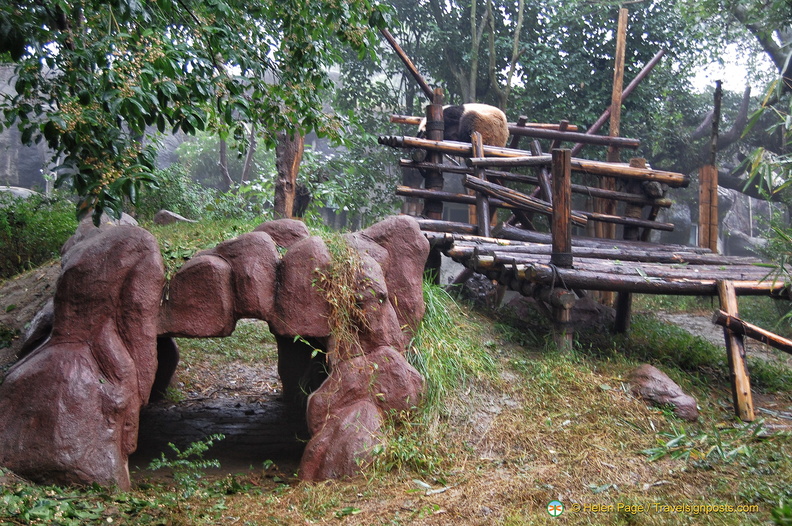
xmin=424 ymin=88 xmax=445 ymax=284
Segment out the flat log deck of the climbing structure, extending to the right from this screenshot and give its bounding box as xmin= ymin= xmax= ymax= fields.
xmin=419 ymin=226 xmax=792 ymax=299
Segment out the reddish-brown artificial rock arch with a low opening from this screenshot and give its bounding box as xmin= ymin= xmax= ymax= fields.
xmin=0 ymin=216 xmax=429 ymax=489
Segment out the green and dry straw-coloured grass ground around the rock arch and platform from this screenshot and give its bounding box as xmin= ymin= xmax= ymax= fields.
xmin=0 ymin=217 xmax=792 ymax=526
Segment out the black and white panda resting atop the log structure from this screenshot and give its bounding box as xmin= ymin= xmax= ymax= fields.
xmin=418 ymin=103 xmax=509 ymax=147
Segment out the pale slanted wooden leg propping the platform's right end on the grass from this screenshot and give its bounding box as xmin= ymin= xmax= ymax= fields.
xmin=717 ymin=280 xmax=756 ymax=422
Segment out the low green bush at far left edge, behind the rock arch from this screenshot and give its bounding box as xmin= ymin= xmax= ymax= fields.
xmin=0 ymin=192 xmax=77 ymax=279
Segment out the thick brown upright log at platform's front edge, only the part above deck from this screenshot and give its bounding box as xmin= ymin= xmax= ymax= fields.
xmin=550 ymin=150 xmax=573 ymax=267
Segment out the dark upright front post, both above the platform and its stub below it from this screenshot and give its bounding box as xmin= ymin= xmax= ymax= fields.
xmin=550 ymin=150 xmax=573 ymax=351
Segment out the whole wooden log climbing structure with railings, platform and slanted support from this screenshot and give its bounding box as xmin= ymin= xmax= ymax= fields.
xmin=379 ymin=17 xmax=792 ymax=421
